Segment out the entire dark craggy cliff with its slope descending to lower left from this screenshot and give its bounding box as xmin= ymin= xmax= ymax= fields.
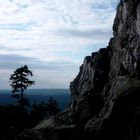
xmin=19 ymin=0 xmax=140 ymax=140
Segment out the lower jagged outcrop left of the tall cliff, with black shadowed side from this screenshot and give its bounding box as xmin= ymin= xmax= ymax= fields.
xmin=71 ymin=48 xmax=110 ymax=125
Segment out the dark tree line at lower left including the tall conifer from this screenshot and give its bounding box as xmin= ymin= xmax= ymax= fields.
xmin=0 ymin=65 xmax=60 ymax=140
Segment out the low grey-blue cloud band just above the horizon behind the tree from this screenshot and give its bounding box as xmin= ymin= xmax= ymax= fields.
xmin=0 ymin=54 xmax=77 ymax=88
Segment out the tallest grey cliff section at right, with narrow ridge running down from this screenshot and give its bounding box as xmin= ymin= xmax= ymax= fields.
xmin=85 ymin=0 xmax=140 ymax=137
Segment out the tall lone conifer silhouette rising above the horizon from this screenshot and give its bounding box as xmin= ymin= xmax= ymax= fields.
xmin=9 ymin=65 xmax=35 ymax=106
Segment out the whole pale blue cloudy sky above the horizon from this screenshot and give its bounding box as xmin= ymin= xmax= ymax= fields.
xmin=0 ymin=0 xmax=118 ymax=89
